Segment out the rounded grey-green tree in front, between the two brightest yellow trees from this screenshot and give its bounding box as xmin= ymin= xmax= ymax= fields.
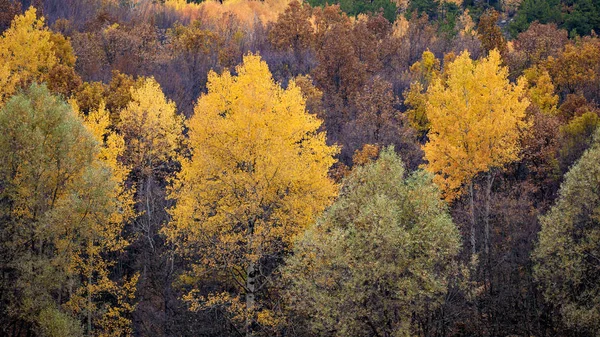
xmin=283 ymin=147 xmax=460 ymax=336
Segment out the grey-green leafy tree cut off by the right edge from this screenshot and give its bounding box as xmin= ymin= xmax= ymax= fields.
xmin=533 ymin=128 xmax=600 ymax=336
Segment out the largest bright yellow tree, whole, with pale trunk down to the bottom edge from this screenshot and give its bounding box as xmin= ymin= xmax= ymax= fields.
xmin=165 ymin=55 xmax=337 ymax=335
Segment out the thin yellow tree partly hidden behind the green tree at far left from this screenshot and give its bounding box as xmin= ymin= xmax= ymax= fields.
xmin=68 ymin=101 xmax=138 ymax=336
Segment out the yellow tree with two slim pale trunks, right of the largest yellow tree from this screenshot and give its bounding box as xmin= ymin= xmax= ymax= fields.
xmin=423 ymin=50 xmax=529 ymax=256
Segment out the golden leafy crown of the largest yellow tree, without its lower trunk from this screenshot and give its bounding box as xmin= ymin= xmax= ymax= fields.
xmin=166 ymin=55 xmax=337 ymax=265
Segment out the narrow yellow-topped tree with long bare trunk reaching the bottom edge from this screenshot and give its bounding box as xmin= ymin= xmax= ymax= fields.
xmin=115 ymin=77 xmax=184 ymax=335
